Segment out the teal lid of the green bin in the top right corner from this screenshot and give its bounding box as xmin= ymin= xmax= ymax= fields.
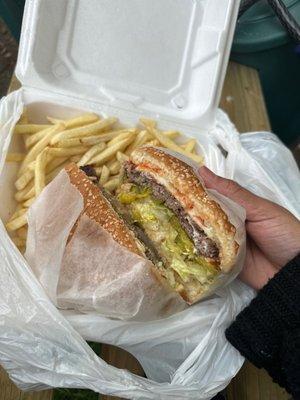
xmin=232 ymin=0 xmax=300 ymax=53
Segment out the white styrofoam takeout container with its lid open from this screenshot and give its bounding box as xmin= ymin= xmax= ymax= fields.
xmin=0 ymin=0 xmax=239 ymax=221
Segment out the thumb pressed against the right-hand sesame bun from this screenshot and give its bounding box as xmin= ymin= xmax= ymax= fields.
xmin=199 ymin=167 xmax=272 ymax=221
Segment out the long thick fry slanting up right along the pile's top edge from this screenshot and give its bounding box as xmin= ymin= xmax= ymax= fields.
xmin=51 ymin=117 xmax=117 ymax=145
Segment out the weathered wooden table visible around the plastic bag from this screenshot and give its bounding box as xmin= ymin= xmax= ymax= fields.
xmin=0 ymin=63 xmax=289 ymax=400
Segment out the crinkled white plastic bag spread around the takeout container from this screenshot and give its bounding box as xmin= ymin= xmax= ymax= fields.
xmin=0 ymin=91 xmax=300 ymax=400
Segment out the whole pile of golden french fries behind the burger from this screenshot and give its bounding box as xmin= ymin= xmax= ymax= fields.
xmin=6 ymin=112 xmax=203 ymax=249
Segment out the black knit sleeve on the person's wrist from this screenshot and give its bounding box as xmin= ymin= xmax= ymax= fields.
xmin=226 ymin=255 xmax=300 ymax=399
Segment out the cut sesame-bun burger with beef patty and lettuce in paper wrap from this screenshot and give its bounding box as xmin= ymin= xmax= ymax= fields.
xmin=67 ymin=147 xmax=239 ymax=304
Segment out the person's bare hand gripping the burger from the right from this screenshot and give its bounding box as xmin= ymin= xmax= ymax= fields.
xmin=200 ymin=167 xmax=300 ymax=290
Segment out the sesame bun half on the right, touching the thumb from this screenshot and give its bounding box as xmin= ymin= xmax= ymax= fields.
xmin=130 ymin=146 xmax=239 ymax=272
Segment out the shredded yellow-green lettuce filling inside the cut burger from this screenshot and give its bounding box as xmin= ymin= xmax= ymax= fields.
xmin=118 ymin=185 xmax=217 ymax=284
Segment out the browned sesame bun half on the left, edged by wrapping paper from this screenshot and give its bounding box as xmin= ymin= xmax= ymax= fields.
xmin=65 ymin=163 xmax=143 ymax=255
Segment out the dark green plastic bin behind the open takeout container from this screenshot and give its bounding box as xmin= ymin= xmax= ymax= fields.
xmin=231 ymin=0 xmax=300 ymax=145
